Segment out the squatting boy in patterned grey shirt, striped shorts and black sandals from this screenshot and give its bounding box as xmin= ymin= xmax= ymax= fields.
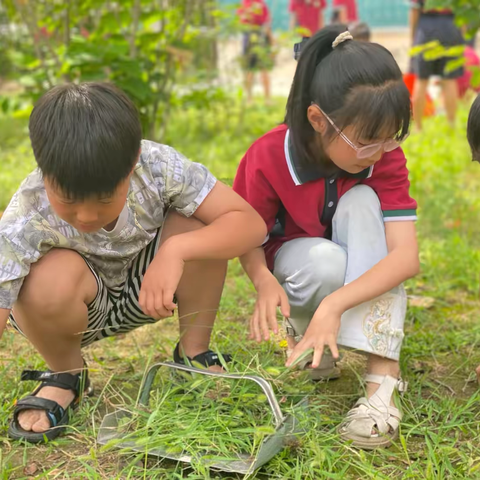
xmin=0 ymin=83 xmax=266 ymax=442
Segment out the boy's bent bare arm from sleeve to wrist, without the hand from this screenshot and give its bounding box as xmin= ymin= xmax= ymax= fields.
xmin=162 ymin=182 xmax=267 ymax=261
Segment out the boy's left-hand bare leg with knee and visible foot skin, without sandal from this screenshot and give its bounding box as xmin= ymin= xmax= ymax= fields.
xmin=13 ymin=250 xmax=97 ymax=432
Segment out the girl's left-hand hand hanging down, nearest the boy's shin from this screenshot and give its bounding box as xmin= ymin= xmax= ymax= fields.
xmin=250 ymin=273 xmax=290 ymax=342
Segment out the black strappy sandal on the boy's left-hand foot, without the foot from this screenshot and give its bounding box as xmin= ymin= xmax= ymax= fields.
xmin=8 ymin=364 xmax=93 ymax=443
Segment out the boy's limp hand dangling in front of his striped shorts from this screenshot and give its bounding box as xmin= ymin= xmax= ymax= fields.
xmin=138 ymin=243 xmax=185 ymax=319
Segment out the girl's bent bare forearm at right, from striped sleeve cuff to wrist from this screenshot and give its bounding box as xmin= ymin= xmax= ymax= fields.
xmin=322 ymin=222 xmax=420 ymax=313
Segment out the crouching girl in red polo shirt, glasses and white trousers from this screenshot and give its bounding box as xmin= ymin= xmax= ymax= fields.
xmin=234 ymin=26 xmax=419 ymax=448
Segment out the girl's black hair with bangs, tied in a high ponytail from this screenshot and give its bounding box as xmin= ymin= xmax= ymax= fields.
xmin=285 ymin=25 xmax=411 ymax=164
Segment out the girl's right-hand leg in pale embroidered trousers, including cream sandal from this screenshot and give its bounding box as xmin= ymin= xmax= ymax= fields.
xmin=333 ymin=185 xmax=407 ymax=448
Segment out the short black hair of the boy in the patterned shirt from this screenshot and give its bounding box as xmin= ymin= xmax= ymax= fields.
xmin=29 ymin=82 xmax=142 ymax=200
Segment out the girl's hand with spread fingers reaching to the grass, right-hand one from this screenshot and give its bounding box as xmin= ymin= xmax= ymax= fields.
xmin=285 ymin=297 xmax=342 ymax=368
